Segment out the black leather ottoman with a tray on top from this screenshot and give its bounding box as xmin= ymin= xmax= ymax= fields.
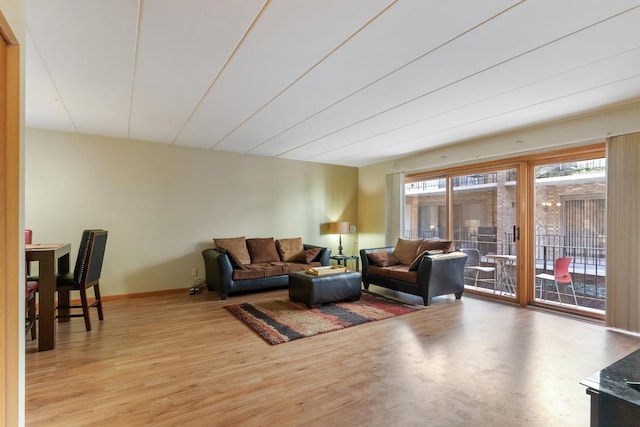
xmin=289 ymin=271 xmax=362 ymax=308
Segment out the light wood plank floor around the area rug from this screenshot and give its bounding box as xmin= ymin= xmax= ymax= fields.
xmin=26 ymin=286 xmax=640 ymax=427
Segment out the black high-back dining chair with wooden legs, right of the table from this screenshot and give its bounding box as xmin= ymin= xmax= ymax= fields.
xmin=56 ymin=230 xmax=108 ymax=331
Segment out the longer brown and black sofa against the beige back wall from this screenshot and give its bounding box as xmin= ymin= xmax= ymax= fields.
xmin=202 ymin=237 xmax=331 ymax=299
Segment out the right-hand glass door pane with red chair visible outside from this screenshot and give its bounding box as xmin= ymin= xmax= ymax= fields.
xmin=533 ymin=158 xmax=607 ymax=313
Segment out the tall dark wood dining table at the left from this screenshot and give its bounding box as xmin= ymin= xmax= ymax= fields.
xmin=25 ymin=243 xmax=71 ymax=351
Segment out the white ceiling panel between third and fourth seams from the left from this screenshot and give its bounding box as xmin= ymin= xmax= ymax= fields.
xmin=177 ymin=0 xmax=390 ymax=147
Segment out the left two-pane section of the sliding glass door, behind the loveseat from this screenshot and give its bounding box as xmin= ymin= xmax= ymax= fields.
xmin=404 ymin=168 xmax=519 ymax=299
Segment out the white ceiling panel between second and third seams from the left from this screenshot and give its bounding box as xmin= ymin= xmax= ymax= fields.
xmin=129 ymin=0 xmax=265 ymax=142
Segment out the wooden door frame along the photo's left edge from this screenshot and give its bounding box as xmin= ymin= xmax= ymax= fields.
xmin=0 ymin=11 xmax=24 ymax=425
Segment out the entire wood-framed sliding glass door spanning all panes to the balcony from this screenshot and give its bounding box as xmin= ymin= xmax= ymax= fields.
xmin=404 ymin=144 xmax=607 ymax=318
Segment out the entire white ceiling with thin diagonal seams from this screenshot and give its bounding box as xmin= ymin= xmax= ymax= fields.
xmin=26 ymin=0 xmax=640 ymax=167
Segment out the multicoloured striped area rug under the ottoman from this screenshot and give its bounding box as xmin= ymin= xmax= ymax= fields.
xmin=224 ymin=291 xmax=424 ymax=344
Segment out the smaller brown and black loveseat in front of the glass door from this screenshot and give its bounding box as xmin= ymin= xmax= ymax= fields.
xmin=360 ymin=239 xmax=467 ymax=305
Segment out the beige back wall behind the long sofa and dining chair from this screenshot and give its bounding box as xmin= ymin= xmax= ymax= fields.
xmin=25 ymin=129 xmax=358 ymax=295
